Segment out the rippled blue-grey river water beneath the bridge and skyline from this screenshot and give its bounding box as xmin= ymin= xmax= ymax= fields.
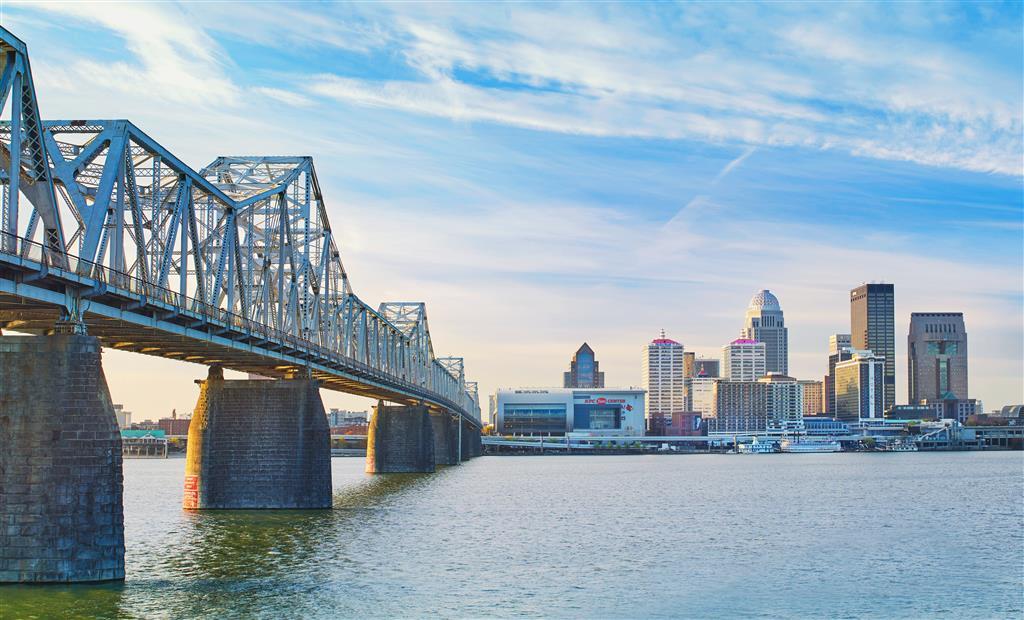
xmin=0 ymin=452 xmax=1024 ymax=619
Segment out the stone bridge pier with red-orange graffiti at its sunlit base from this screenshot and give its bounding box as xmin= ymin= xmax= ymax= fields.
xmin=182 ymin=367 xmax=331 ymax=510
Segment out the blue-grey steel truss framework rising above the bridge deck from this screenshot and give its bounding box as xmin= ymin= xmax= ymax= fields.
xmin=0 ymin=28 xmax=479 ymax=419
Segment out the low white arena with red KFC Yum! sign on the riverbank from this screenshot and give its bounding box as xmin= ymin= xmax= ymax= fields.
xmin=495 ymin=387 xmax=646 ymax=437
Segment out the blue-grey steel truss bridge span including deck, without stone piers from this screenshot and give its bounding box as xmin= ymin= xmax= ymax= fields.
xmin=0 ymin=28 xmax=480 ymax=425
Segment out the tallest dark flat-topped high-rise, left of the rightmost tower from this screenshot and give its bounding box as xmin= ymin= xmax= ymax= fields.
xmin=851 ymin=284 xmax=896 ymax=417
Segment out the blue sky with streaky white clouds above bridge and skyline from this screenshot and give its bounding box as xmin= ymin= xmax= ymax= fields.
xmin=2 ymin=2 xmax=1024 ymax=417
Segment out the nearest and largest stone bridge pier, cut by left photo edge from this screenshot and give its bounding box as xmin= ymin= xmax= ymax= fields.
xmin=0 ymin=334 xmax=125 ymax=583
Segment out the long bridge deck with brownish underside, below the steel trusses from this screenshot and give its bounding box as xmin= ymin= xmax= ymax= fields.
xmin=0 ymin=246 xmax=479 ymax=425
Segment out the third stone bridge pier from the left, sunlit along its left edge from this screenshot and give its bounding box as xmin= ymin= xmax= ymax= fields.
xmin=367 ymin=401 xmax=434 ymax=473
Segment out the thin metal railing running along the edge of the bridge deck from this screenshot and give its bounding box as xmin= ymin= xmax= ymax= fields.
xmin=6 ymin=237 xmax=476 ymax=418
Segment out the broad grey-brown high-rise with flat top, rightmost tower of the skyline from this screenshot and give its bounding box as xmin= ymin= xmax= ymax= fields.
xmin=906 ymin=313 xmax=968 ymax=405
